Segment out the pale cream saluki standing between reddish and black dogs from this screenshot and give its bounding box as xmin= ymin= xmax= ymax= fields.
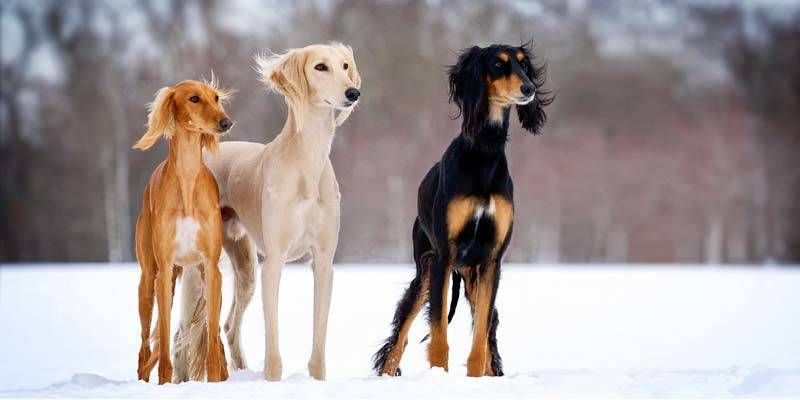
xmin=184 ymin=43 xmax=361 ymax=381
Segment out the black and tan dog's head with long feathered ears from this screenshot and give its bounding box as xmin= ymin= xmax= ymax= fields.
xmin=449 ymin=44 xmax=552 ymax=138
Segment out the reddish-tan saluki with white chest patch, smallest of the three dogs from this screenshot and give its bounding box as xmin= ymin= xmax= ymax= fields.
xmin=133 ymin=78 xmax=233 ymax=384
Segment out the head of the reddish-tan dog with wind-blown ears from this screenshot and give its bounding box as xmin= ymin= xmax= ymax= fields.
xmin=133 ymin=74 xmax=233 ymax=152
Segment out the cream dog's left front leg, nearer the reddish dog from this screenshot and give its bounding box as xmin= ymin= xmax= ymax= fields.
xmin=261 ymin=252 xmax=283 ymax=381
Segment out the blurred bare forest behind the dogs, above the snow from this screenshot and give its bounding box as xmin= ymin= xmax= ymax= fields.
xmin=0 ymin=0 xmax=800 ymax=263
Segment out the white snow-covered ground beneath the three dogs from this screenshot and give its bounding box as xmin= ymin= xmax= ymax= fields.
xmin=0 ymin=264 xmax=800 ymax=399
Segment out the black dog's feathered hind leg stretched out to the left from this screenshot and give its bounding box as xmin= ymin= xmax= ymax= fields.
xmin=372 ymin=221 xmax=435 ymax=376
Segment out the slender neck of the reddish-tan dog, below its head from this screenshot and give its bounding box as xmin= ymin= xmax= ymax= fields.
xmin=164 ymin=129 xmax=205 ymax=213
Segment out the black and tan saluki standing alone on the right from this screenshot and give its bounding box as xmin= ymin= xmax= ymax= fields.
xmin=374 ymin=45 xmax=552 ymax=376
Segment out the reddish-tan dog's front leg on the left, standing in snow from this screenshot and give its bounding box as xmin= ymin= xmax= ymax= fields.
xmin=156 ymin=260 xmax=172 ymax=385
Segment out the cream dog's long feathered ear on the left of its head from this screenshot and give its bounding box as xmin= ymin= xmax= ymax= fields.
xmin=255 ymin=49 xmax=309 ymax=131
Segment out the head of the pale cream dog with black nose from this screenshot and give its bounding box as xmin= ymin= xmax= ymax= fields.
xmin=256 ymin=42 xmax=361 ymax=131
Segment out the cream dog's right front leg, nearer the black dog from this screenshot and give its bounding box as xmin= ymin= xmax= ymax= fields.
xmin=308 ymin=246 xmax=335 ymax=380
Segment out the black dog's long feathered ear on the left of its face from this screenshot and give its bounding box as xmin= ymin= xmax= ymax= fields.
xmin=449 ymin=46 xmax=488 ymax=139
